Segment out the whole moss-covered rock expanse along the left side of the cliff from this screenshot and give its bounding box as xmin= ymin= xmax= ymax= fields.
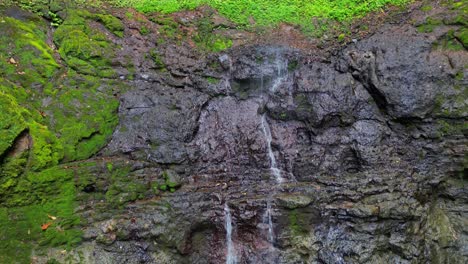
xmin=0 ymin=7 xmax=126 ymax=263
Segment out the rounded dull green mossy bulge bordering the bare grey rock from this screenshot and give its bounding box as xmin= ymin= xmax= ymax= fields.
xmin=44 ymin=71 xmax=121 ymax=161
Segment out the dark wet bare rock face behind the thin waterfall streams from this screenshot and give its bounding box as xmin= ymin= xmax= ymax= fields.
xmin=66 ymin=15 xmax=468 ymax=263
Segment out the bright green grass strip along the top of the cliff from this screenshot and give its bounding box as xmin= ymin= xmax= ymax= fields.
xmin=110 ymin=0 xmax=410 ymax=26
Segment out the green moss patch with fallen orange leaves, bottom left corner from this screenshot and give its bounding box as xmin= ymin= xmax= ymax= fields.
xmin=0 ymin=167 xmax=81 ymax=263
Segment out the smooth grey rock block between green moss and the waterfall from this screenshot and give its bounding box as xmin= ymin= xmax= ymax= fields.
xmin=108 ymin=83 xmax=208 ymax=164
